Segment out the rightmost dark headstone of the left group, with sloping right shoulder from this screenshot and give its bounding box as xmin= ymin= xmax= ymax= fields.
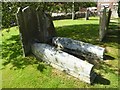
xmin=36 ymin=8 xmax=56 ymax=43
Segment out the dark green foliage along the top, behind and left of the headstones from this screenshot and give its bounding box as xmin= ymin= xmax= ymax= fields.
xmin=2 ymin=2 xmax=96 ymax=28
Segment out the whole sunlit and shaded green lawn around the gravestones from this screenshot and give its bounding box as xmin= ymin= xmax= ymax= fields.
xmin=0 ymin=17 xmax=120 ymax=88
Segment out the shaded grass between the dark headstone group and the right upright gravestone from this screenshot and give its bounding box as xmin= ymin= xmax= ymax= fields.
xmin=56 ymin=24 xmax=99 ymax=43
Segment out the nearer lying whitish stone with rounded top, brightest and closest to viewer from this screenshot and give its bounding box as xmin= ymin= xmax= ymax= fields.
xmin=31 ymin=43 xmax=95 ymax=83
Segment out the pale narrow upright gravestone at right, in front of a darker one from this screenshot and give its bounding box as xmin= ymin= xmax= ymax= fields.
xmin=99 ymin=7 xmax=107 ymax=41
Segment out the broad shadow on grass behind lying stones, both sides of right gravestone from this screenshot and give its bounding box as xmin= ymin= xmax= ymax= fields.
xmin=56 ymin=24 xmax=120 ymax=45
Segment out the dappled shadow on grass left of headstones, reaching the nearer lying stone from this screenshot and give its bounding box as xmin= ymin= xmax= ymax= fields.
xmin=2 ymin=35 xmax=45 ymax=72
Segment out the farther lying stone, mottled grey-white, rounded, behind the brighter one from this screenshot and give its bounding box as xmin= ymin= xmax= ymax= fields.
xmin=52 ymin=37 xmax=105 ymax=60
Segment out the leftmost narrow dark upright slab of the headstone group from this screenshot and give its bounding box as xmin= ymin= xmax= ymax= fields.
xmin=17 ymin=8 xmax=30 ymax=56
